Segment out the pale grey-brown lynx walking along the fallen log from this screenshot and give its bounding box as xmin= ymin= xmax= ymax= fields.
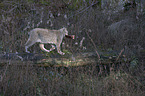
xmin=25 ymin=28 xmax=68 ymax=55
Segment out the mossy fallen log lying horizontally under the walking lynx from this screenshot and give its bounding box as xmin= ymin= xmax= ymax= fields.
xmin=0 ymin=52 xmax=129 ymax=67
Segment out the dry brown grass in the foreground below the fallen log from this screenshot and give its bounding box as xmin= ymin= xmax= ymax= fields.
xmin=0 ymin=63 xmax=144 ymax=96
